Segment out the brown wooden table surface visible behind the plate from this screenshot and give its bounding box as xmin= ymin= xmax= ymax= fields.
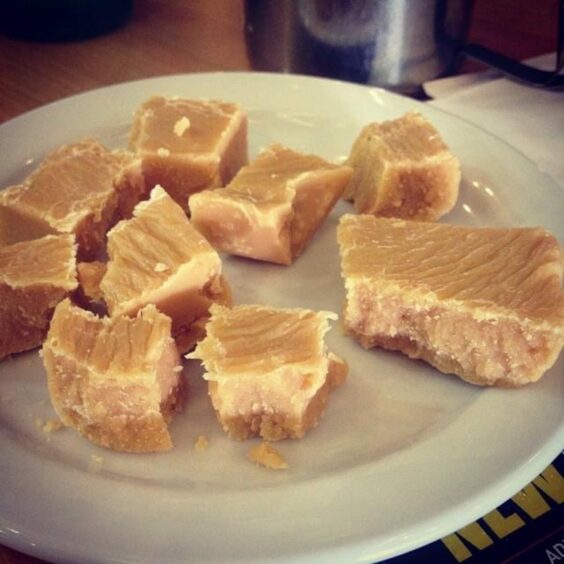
xmin=0 ymin=0 xmax=558 ymax=564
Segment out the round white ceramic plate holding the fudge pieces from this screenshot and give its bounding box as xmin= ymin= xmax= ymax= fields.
xmin=0 ymin=73 xmax=564 ymax=563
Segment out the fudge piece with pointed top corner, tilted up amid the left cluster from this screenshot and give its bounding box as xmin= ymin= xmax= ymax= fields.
xmin=100 ymin=186 xmax=231 ymax=352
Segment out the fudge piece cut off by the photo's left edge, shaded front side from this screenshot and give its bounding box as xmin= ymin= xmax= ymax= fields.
xmin=0 ymin=235 xmax=77 ymax=359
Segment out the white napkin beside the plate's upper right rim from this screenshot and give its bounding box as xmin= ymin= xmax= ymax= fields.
xmin=423 ymin=54 xmax=564 ymax=189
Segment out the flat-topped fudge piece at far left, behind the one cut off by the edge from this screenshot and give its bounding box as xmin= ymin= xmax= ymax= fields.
xmin=0 ymin=139 xmax=145 ymax=260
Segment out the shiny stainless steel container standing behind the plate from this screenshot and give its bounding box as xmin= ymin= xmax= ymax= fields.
xmin=246 ymin=0 xmax=473 ymax=93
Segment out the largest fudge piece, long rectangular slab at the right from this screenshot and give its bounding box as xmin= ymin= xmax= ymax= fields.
xmin=338 ymin=215 xmax=564 ymax=387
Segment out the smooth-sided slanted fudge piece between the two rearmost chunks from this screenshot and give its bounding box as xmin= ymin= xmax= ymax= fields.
xmin=190 ymin=144 xmax=352 ymax=265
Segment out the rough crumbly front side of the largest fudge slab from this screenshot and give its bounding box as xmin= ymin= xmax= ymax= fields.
xmin=343 ymin=280 xmax=564 ymax=387
